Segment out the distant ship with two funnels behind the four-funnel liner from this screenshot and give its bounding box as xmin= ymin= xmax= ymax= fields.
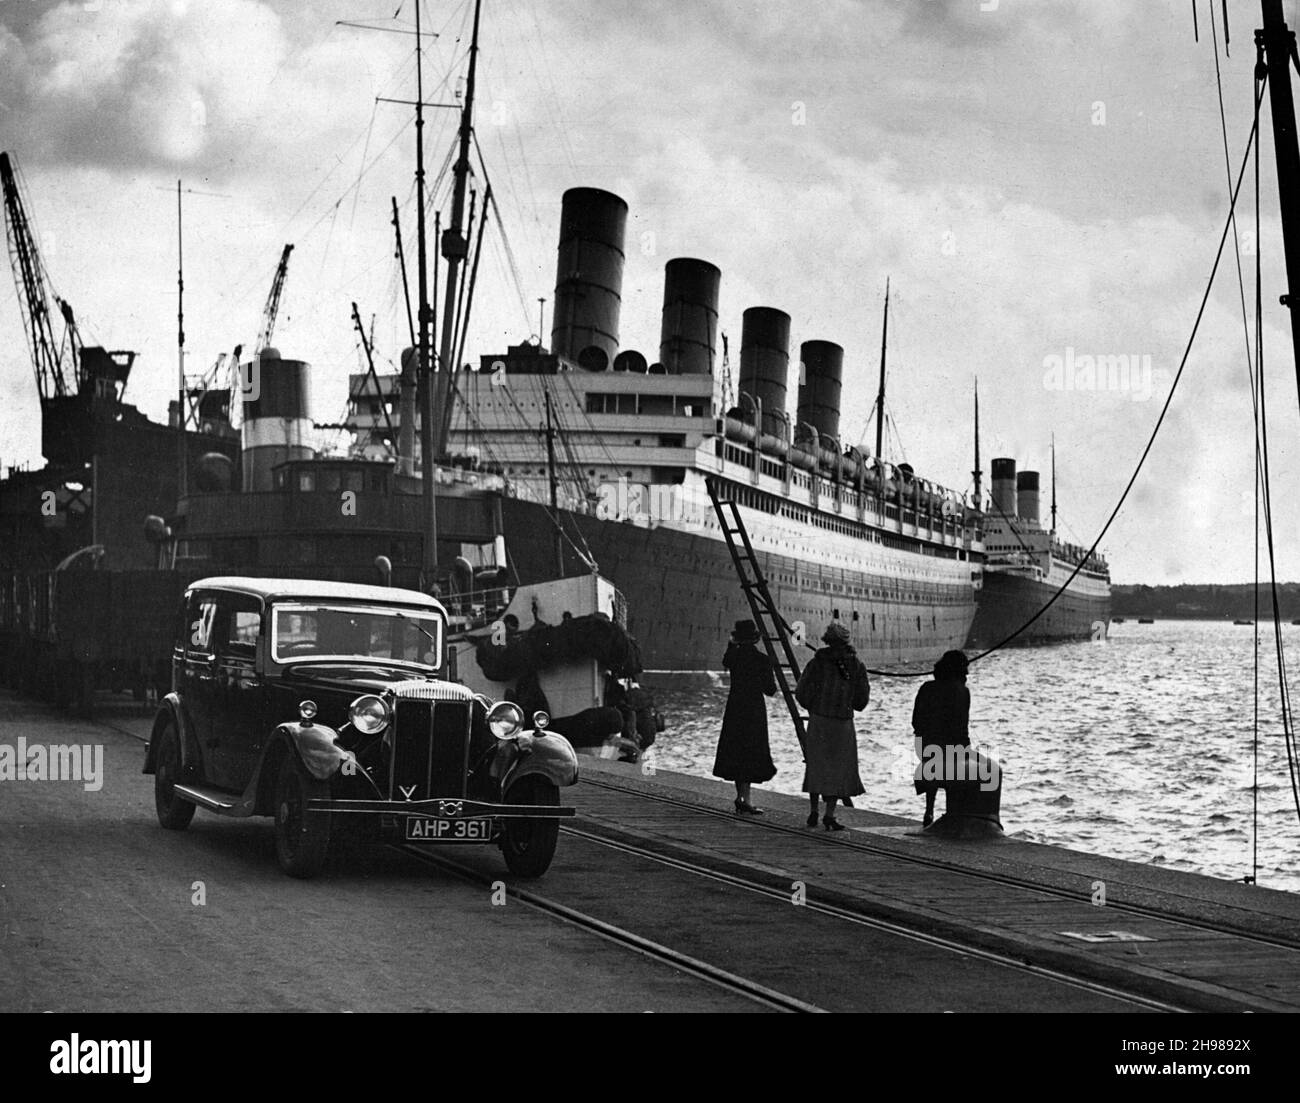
xmin=966 ymin=458 xmax=1110 ymax=648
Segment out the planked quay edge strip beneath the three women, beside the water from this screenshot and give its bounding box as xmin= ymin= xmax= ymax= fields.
xmin=580 ymin=762 xmax=1300 ymax=1012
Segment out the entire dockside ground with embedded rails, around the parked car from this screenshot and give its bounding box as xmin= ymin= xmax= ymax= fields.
xmin=0 ymin=695 xmax=1300 ymax=1012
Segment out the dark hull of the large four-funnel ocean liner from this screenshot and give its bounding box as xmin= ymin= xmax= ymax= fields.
xmin=502 ymin=498 xmax=975 ymax=671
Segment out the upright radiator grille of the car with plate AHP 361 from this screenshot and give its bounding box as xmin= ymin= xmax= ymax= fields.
xmin=389 ymin=683 xmax=472 ymax=800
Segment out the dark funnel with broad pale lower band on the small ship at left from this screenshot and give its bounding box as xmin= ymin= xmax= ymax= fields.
xmin=242 ymin=349 xmax=315 ymax=490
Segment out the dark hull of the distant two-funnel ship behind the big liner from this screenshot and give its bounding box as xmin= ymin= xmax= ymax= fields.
xmin=966 ymin=570 xmax=1110 ymax=648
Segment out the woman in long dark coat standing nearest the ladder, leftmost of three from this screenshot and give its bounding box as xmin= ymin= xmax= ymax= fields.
xmin=714 ymin=620 xmax=776 ymax=816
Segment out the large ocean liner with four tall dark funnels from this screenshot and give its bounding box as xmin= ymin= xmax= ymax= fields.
xmin=347 ymin=187 xmax=983 ymax=670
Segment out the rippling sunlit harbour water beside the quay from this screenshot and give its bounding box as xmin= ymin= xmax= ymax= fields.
xmin=655 ymin=620 xmax=1300 ymax=892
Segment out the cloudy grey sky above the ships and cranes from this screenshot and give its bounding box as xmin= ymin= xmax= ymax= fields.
xmin=0 ymin=0 xmax=1300 ymax=583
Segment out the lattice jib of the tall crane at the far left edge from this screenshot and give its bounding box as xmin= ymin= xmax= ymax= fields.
xmin=0 ymin=152 xmax=82 ymax=403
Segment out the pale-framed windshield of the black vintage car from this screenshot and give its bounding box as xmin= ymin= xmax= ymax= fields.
xmin=270 ymin=604 xmax=442 ymax=667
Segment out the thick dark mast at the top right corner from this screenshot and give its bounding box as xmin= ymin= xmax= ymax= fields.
xmin=1255 ymin=0 xmax=1300 ymax=386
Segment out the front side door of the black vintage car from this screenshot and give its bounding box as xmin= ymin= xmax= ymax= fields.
xmin=211 ymin=593 xmax=267 ymax=792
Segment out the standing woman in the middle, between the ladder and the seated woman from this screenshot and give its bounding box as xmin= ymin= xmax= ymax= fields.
xmin=794 ymin=620 xmax=871 ymax=831
